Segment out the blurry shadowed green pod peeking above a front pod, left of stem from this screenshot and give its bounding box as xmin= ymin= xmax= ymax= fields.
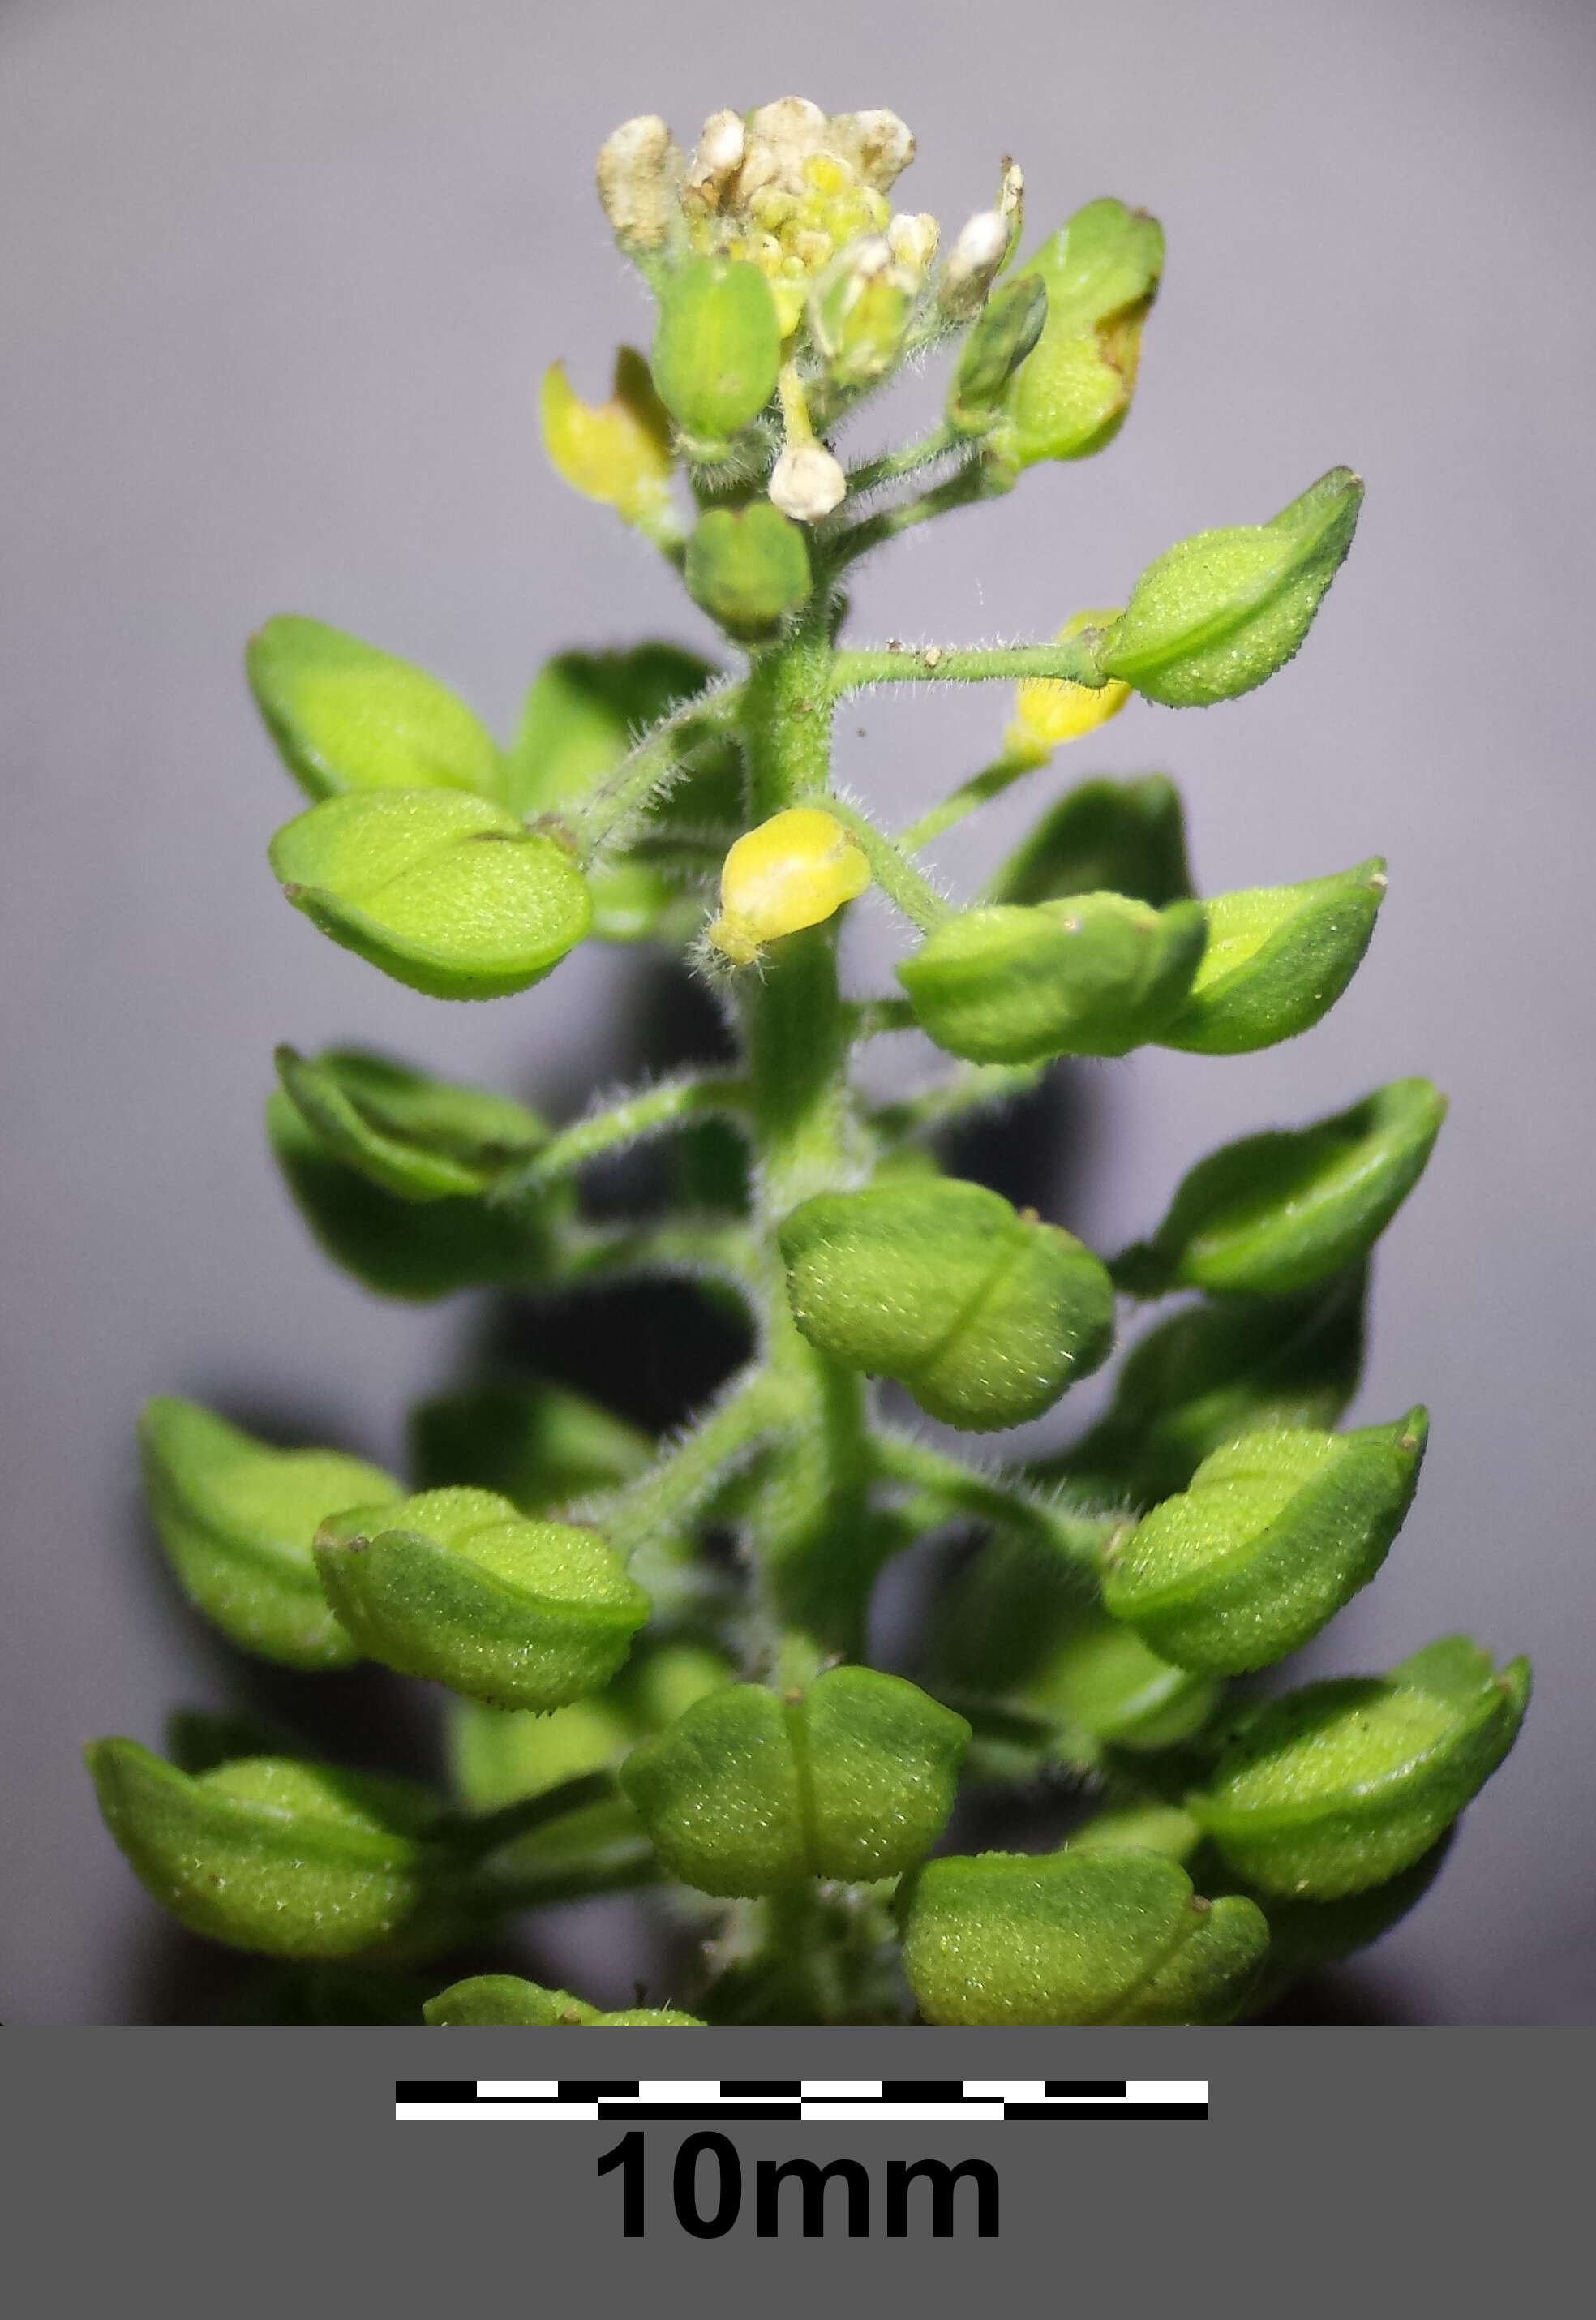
xmin=408 ymin=1383 xmax=654 ymax=1515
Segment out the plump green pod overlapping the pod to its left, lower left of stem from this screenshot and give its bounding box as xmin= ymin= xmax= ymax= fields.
xmin=315 ymin=1489 xmax=650 ymax=1708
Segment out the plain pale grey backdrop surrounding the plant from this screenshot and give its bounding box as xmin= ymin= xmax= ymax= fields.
xmin=0 ymin=0 xmax=1596 ymax=2023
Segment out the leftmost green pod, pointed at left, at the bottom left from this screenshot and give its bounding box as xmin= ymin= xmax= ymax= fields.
xmin=84 ymin=1740 xmax=436 ymax=1958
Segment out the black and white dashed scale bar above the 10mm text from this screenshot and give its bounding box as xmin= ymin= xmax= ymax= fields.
xmin=394 ymin=2079 xmax=1208 ymax=2125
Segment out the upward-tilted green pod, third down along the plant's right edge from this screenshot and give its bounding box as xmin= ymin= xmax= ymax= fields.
xmin=1116 ymin=1079 xmax=1445 ymax=1297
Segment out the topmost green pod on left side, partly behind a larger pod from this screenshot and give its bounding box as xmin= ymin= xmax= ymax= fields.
xmin=243 ymin=612 xmax=499 ymax=798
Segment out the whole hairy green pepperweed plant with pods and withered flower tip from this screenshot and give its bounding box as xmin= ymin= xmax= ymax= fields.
xmin=88 ymin=97 xmax=1529 ymax=2023
